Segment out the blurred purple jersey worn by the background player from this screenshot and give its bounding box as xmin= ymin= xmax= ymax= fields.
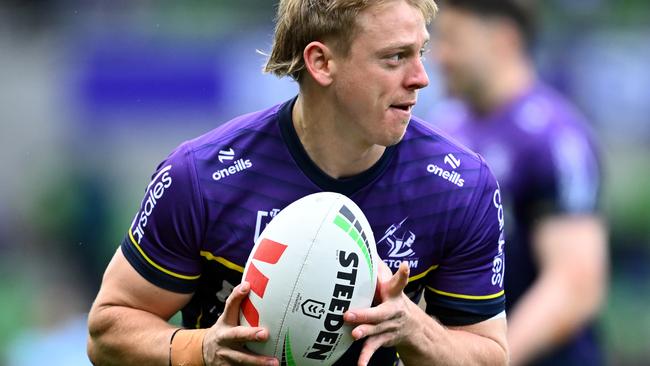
xmin=432 ymin=84 xmax=603 ymax=365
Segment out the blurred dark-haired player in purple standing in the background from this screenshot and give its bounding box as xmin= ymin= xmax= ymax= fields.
xmin=432 ymin=0 xmax=608 ymax=365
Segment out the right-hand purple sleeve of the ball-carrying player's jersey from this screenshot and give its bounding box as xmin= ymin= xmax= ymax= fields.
xmin=424 ymin=158 xmax=505 ymax=325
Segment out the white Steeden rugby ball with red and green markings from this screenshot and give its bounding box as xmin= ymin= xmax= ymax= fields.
xmin=240 ymin=192 xmax=379 ymax=366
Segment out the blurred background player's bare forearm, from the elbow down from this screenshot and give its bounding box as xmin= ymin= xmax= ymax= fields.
xmin=508 ymin=273 xmax=604 ymax=365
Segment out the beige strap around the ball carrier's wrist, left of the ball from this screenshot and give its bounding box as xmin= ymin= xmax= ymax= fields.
xmin=169 ymin=329 xmax=207 ymax=366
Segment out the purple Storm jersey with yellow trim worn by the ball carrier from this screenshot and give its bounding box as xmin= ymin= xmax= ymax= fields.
xmin=122 ymin=99 xmax=505 ymax=364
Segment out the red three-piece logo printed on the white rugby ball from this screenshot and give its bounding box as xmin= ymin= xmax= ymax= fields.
xmin=241 ymin=239 xmax=287 ymax=327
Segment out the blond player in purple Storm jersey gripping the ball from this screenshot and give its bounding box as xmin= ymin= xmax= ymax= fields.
xmin=88 ymin=0 xmax=508 ymax=366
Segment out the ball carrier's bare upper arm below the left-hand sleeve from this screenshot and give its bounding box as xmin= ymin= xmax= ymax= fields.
xmin=91 ymin=249 xmax=192 ymax=320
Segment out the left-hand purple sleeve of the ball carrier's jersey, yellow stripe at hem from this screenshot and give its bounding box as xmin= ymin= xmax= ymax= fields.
xmin=121 ymin=145 xmax=204 ymax=293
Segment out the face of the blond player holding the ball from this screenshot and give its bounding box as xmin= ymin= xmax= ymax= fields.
xmin=332 ymin=0 xmax=429 ymax=146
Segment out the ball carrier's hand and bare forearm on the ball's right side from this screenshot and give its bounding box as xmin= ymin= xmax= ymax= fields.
xmin=345 ymin=262 xmax=508 ymax=365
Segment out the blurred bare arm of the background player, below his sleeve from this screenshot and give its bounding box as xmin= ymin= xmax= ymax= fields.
xmin=508 ymin=215 xmax=608 ymax=365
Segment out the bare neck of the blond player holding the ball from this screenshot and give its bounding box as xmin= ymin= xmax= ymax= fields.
xmin=292 ymin=88 xmax=386 ymax=179
